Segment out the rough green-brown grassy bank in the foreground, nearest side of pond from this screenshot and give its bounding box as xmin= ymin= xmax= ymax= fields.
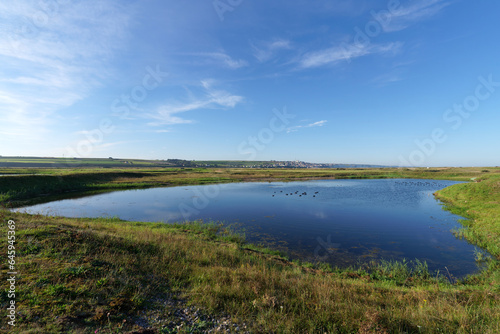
xmin=0 ymin=211 xmax=500 ymax=333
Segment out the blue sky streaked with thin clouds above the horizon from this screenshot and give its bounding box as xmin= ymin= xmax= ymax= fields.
xmin=0 ymin=0 xmax=500 ymax=166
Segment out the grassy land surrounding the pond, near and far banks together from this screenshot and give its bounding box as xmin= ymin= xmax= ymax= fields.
xmin=0 ymin=169 xmax=500 ymax=333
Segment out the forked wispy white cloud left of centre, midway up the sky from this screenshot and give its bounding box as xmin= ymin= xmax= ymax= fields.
xmin=146 ymin=79 xmax=243 ymax=126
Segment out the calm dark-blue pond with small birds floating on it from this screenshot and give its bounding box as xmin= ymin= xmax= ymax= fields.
xmin=19 ymin=179 xmax=478 ymax=277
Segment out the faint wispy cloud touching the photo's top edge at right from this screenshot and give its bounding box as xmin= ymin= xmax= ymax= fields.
xmin=378 ymin=0 xmax=450 ymax=32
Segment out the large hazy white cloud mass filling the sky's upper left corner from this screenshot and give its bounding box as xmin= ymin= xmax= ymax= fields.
xmin=0 ymin=0 xmax=130 ymax=137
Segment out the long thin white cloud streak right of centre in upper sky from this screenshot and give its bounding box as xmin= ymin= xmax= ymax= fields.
xmin=299 ymin=42 xmax=403 ymax=68
